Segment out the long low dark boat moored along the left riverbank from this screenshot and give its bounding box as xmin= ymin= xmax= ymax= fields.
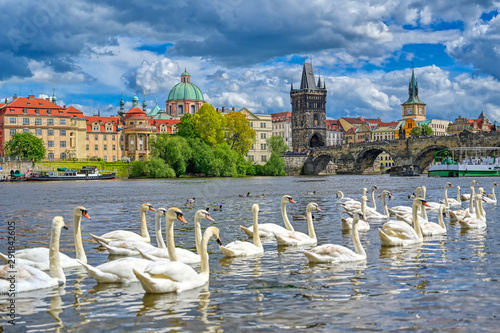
xmin=28 ymin=166 xmax=116 ymax=181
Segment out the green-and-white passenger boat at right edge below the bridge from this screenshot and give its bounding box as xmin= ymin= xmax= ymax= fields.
xmin=429 ymin=147 xmax=500 ymax=177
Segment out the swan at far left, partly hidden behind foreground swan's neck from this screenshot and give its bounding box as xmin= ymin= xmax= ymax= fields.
xmin=0 ymin=206 xmax=91 ymax=271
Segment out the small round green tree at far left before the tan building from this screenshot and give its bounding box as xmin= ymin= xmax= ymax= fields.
xmin=4 ymin=133 xmax=46 ymax=162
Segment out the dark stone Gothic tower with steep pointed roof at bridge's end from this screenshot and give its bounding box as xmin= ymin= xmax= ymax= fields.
xmin=290 ymin=63 xmax=326 ymax=152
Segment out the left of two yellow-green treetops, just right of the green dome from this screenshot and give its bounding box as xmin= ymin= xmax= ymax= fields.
xmin=192 ymin=103 xmax=225 ymax=147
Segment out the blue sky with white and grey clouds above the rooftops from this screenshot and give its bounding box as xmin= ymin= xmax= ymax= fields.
xmin=0 ymin=0 xmax=500 ymax=121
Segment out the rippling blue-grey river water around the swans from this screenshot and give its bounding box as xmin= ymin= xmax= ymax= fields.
xmin=0 ymin=175 xmax=500 ymax=332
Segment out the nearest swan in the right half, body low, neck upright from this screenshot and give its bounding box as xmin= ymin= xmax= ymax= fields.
xmin=303 ymin=213 xmax=366 ymax=263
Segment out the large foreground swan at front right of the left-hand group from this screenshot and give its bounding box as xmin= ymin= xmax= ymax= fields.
xmin=133 ymin=227 xmax=222 ymax=293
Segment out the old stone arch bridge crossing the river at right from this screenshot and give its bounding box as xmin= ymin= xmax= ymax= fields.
xmin=285 ymin=132 xmax=500 ymax=175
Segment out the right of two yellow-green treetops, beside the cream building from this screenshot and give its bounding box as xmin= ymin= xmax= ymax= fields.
xmin=224 ymin=111 xmax=255 ymax=155
